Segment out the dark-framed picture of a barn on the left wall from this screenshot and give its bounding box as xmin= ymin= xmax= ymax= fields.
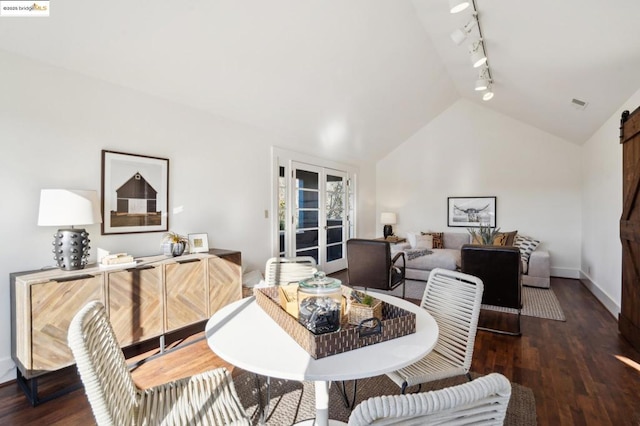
xmin=101 ymin=150 xmax=169 ymax=235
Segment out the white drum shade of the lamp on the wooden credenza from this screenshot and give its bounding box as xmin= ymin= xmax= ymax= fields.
xmin=38 ymin=189 xmax=102 ymax=226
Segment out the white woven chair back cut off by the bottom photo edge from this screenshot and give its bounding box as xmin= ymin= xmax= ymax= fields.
xmin=348 ymin=373 xmax=511 ymax=426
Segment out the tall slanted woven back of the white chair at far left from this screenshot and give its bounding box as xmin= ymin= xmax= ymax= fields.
xmin=69 ymin=302 xmax=139 ymax=425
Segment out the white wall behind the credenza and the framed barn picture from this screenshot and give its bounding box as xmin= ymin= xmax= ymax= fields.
xmin=0 ymin=52 xmax=374 ymax=382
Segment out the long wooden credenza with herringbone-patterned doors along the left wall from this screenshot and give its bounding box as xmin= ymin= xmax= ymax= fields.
xmin=10 ymin=249 xmax=242 ymax=394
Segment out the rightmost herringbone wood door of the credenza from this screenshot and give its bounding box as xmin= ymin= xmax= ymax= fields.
xmin=209 ymin=252 xmax=242 ymax=316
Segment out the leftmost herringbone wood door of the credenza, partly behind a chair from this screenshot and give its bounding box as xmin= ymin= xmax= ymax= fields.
xmin=26 ymin=275 xmax=104 ymax=378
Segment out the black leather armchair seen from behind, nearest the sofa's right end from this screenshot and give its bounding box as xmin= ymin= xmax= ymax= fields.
xmin=461 ymin=244 xmax=522 ymax=336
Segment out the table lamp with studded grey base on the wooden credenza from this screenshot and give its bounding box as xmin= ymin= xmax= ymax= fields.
xmin=38 ymin=189 xmax=102 ymax=271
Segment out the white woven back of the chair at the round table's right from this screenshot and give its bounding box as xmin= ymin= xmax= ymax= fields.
xmin=420 ymin=268 xmax=484 ymax=371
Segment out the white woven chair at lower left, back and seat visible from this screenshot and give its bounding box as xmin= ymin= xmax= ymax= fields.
xmin=68 ymin=301 xmax=251 ymax=426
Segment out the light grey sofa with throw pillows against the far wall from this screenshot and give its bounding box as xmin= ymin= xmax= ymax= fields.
xmin=391 ymin=232 xmax=551 ymax=288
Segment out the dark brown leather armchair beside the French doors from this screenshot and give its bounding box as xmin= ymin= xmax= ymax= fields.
xmin=347 ymin=238 xmax=406 ymax=299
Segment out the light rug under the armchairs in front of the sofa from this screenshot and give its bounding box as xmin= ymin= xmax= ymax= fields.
xmin=370 ymin=280 xmax=566 ymax=321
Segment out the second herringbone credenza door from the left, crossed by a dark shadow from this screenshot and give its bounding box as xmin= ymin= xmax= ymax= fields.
xmin=107 ymin=265 xmax=164 ymax=346
